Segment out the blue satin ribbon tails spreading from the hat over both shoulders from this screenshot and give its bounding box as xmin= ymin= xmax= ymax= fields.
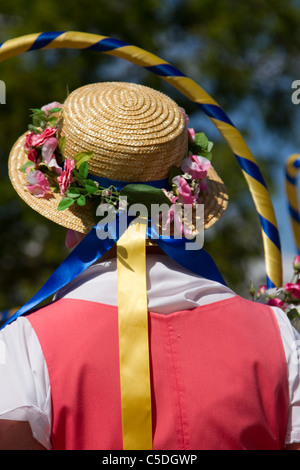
xmin=1 ymin=213 xmax=225 ymax=329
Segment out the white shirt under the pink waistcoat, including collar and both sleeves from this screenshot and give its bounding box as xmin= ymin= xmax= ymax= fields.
xmin=0 ymin=255 xmax=300 ymax=449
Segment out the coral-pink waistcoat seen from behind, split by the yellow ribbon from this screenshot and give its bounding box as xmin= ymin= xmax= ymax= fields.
xmin=27 ymin=296 xmax=289 ymax=450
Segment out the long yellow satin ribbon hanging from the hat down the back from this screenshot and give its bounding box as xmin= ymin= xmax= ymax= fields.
xmin=117 ymin=218 xmax=152 ymax=450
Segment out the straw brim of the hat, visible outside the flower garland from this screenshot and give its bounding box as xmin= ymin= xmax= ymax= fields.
xmin=8 ymin=133 xmax=228 ymax=233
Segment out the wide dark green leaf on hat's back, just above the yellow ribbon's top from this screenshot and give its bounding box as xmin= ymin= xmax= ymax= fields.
xmin=120 ymin=184 xmax=172 ymax=214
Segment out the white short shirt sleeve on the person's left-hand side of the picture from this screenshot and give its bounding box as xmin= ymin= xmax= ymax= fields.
xmin=0 ymin=317 xmax=51 ymax=449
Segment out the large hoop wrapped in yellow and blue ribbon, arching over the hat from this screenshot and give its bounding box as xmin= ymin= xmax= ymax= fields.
xmin=0 ymin=31 xmax=282 ymax=287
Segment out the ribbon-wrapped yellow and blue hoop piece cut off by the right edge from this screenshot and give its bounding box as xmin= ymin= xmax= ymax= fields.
xmin=285 ymin=153 xmax=300 ymax=254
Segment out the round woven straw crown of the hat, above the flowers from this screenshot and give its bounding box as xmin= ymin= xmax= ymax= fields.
xmin=62 ymin=82 xmax=188 ymax=182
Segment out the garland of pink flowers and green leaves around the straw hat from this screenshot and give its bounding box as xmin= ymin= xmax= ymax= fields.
xmin=19 ymin=101 xmax=213 ymax=242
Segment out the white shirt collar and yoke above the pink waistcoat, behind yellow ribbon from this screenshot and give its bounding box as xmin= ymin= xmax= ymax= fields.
xmin=54 ymin=254 xmax=236 ymax=314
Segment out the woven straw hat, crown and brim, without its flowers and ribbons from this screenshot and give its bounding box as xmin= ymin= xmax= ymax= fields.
xmin=9 ymin=82 xmax=228 ymax=233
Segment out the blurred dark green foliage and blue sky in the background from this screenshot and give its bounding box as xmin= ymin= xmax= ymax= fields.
xmin=0 ymin=0 xmax=300 ymax=310
